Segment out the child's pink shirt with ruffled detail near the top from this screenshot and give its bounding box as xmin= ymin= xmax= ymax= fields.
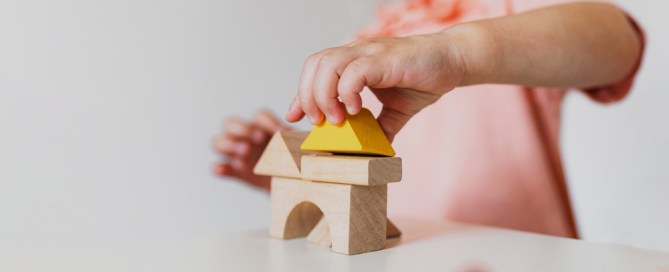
xmin=360 ymin=0 xmax=642 ymax=237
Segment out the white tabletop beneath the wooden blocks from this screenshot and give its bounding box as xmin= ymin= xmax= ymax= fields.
xmin=0 ymin=219 xmax=669 ymax=272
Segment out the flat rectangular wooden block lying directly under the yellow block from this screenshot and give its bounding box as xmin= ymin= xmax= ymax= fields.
xmin=301 ymin=154 xmax=402 ymax=186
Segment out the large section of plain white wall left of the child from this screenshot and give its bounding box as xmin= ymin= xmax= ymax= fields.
xmin=0 ymin=0 xmax=373 ymax=244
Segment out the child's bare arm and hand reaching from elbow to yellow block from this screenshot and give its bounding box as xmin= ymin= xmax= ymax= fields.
xmin=286 ymin=2 xmax=642 ymax=140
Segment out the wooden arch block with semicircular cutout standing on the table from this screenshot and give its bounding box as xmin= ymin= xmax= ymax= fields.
xmin=270 ymin=177 xmax=388 ymax=255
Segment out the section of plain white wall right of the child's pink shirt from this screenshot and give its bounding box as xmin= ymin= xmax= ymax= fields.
xmin=562 ymin=0 xmax=669 ymax=251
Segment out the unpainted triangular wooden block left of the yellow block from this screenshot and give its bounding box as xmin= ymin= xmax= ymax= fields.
xmin=253 ymin=131 xmax=314 ymax=178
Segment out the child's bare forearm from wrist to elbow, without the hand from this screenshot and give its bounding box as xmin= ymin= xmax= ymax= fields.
xmin=442 ymin=3 xmax=641 ymax=88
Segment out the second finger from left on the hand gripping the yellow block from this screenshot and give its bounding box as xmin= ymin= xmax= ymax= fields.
xmin=297 ymin=52 xmax=324 ymax=125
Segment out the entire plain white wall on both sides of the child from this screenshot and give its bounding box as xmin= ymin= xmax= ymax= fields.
xmin=0 ymin=0 xmax=669 ymax=251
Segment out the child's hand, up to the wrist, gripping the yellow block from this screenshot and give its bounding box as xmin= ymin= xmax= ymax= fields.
xmin=286 ymin=33 xmax=464 ymax=140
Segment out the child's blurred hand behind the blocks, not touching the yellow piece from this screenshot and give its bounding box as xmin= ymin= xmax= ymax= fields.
xmin=213 ymin=111 xmax=285 ymax=190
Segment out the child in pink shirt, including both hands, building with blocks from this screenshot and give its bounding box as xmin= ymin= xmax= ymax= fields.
xmin=215 ymin=0 xmax=643 ymax=237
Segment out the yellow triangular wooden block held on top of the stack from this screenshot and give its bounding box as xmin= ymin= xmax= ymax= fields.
xmin=301 ymin=108 xmax=395 ymax=157
